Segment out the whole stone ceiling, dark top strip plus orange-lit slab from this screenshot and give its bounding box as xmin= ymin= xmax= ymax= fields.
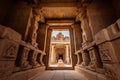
xmin=31 ymin=0 xmax=92 ymax=19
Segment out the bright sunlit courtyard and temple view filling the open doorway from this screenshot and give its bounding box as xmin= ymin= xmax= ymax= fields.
xmin=49 ymin=29 xmax=72 ymax=67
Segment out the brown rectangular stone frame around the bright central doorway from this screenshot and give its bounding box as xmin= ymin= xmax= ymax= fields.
xmin=44 ymin=25 xmax=77 ymax=70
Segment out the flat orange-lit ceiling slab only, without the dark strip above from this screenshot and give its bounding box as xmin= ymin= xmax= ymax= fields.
xmin=42 ymin=7 xmax=78 ymax=18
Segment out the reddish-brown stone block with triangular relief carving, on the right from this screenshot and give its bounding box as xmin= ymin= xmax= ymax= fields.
xmin=99 ymin=42 xmax=119 ymax=63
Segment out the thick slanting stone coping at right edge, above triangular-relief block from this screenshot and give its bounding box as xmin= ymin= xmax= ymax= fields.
xmin=95 ymin=20 xmax=120 ymax=44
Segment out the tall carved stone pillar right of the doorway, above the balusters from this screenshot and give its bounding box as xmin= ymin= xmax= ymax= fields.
xmin=76 ymin=8 xmax=92 ymax=45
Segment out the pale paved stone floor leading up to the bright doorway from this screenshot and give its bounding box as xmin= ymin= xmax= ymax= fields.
xmin=30 ymin=70 xmax=87 ymax=80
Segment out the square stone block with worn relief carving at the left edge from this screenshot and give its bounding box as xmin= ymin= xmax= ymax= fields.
xmin=0 ymin=39 xmax=19 ymax=60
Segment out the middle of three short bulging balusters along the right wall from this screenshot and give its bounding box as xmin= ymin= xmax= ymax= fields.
xmin=81 ymin=51 xmax=90 ymax=66
